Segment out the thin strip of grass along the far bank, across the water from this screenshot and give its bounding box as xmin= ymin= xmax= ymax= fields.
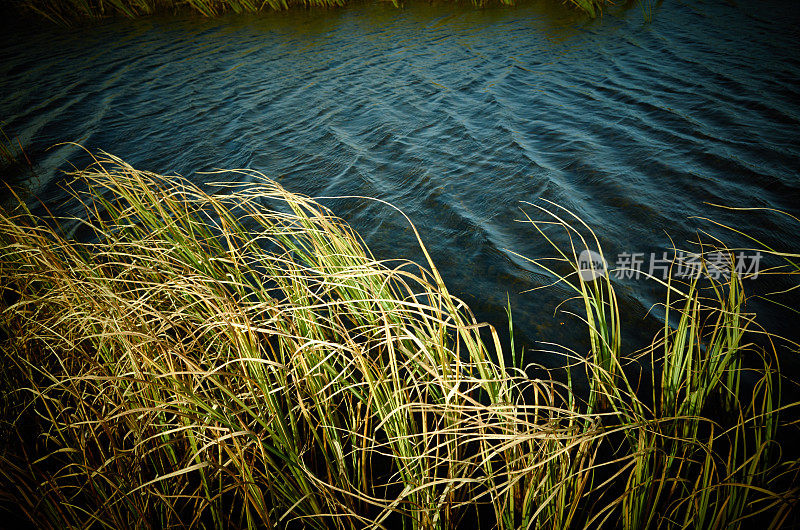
xmin=8 ymin=0 xmax=612 ymax=25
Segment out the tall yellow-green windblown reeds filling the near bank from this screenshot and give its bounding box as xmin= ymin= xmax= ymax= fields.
xmin=0 ymin=155 xmax=800 ymax=529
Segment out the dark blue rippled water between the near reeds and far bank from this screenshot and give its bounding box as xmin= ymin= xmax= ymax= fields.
xmin=0 ymin=0 xmax=800 ymax=362
